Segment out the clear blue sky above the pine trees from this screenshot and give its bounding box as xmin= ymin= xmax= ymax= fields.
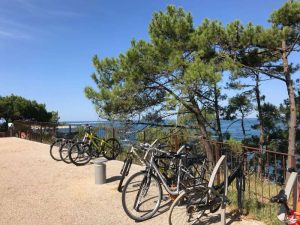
xmin=0 ymin=0 xmax=299 ymax=121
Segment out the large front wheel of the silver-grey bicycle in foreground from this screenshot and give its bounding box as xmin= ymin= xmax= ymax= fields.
xmin=122 ymin=171 xmax=162 ymax=221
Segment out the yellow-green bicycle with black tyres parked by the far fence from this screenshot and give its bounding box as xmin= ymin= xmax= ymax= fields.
xmin=68 ymin=126 xmax=121 ymax=166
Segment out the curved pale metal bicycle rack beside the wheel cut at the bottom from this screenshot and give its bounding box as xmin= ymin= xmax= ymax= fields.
xmin=208 ymin=155 xmax=228 ymax=225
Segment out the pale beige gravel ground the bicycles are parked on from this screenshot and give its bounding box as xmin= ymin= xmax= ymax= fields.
xmin=0 ymin=138 xmax=263 ymax=225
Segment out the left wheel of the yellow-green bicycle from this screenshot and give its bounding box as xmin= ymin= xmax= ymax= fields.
xmin=68 ymin=142 xmax=91 ymax=166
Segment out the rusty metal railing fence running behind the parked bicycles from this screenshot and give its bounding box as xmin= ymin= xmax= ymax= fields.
xmin=10 ymin=121 xmax=295 ymax=222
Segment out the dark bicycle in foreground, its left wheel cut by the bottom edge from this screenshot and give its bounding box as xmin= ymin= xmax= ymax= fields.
xmin=168 ymin=151 xmax=245 ymax=225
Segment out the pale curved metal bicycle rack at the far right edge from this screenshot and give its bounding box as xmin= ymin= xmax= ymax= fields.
xmin=277 ymin=172 xmax=298 ymax=222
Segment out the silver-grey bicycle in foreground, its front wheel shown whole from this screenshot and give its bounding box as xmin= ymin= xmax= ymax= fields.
xmin=122 ymin=145 xmax=205 ymax=221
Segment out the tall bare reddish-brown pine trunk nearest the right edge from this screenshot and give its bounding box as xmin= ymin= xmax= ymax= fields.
xmin=282 ymin=40 xmax=297 ymax=168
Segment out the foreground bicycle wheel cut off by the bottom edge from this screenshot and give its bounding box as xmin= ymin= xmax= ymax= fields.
xmin=168 ymin=187 xmax=207 ymax=225
